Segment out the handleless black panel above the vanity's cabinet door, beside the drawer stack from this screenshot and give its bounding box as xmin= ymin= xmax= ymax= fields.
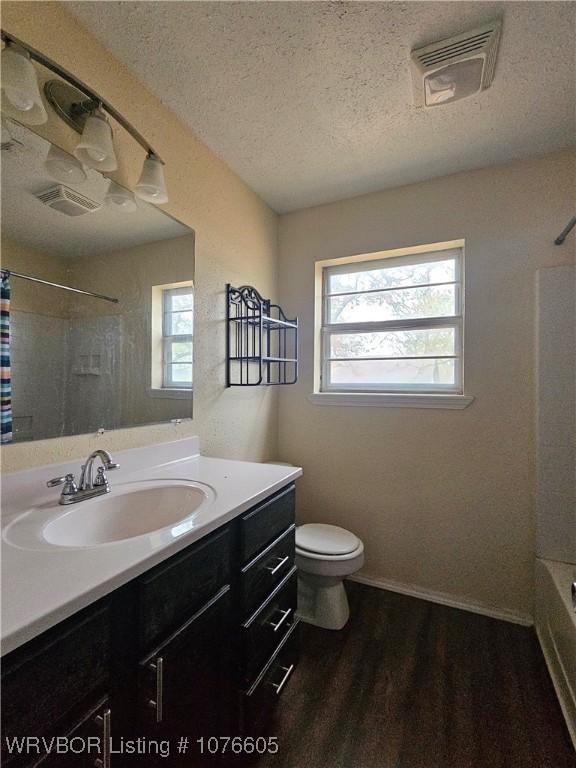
xmin=138 ymin=528 xmax=231 ymax=653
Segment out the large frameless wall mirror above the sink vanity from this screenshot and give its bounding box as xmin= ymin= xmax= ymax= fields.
xmin=1 ymin=118 xmax=194 ymax=442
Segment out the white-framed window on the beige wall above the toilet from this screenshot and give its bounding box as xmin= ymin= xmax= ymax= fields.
xmin=319 ymin=247 xmax=463 ymax=394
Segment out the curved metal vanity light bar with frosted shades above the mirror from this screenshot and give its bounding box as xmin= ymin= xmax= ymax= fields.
xmin=1 ymin=30 xmax=168 ymax=205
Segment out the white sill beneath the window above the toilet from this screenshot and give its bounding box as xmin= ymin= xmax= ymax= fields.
xmin=308 ymin=392 xmax=474 ymax=410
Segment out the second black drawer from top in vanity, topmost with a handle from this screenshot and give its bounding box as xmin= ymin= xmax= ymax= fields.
xmin=241 ymin=525 xmax=296 ymax=617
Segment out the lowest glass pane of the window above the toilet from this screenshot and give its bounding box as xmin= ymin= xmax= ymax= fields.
xmin=328 ymin=359 xmax=455 ymax=389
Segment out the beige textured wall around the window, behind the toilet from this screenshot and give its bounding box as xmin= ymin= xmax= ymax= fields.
xmin=279 ymin=152 xmax=575 ymax=614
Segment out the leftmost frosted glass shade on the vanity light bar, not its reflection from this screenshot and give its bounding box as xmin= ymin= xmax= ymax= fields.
xmin=2 ymin=45 xmax=48 ymax=125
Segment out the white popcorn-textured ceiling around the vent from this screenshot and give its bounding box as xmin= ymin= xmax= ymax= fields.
xmin=67 ymin=0 xmax=576 ymax=212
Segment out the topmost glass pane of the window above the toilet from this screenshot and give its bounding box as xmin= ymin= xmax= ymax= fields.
xmin=328 ymin=259 xmax=456 ymax=293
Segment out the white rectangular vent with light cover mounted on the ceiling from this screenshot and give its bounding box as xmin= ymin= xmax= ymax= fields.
xmin=411 ymin=19 xmax=502 ymax=107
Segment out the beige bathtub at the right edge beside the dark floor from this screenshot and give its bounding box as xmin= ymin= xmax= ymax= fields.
xmin=536 ymin=560 xmax=576 ymax=748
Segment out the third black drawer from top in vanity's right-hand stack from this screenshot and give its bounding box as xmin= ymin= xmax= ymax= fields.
xmin=242 ymin=568 xmax=297 ymax=685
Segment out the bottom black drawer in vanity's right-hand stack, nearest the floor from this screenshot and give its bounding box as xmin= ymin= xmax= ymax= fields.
xmin=242 ymin=620 xmax=300 ymax=735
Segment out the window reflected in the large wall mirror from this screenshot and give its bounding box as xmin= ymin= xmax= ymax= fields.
xmin=162 ymin=285 xmax=194 ymax=389
